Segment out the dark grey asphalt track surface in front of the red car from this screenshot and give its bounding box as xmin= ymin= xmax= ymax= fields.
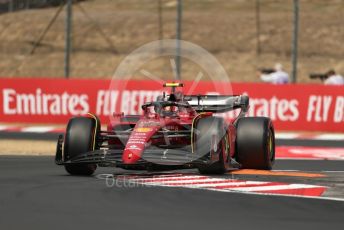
xmin=0 ymin=156 xmax=344 ymax=230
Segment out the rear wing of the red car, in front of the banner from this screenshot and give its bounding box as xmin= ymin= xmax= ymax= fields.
xmin=184 ymin=95 xmax=249 ymax=113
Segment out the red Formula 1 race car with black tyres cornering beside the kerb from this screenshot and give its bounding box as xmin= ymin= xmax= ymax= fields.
xmin=55 ymin=83 xmax=275 ymax=175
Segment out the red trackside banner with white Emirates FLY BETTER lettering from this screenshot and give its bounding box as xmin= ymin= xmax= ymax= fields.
xmin=0 ymin=79 xmax=344 ymax=132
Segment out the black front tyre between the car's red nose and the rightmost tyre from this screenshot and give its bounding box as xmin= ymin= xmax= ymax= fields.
xmin=194 ymin=117 xmax=228 ymax=174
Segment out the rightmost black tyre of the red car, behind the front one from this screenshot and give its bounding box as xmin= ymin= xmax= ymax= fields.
xmin=236 ymin=117 xmax=275 ymax=170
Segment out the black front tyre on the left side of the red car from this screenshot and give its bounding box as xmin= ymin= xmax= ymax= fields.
xmin=64 ymin=117 xmax=100 ymax=176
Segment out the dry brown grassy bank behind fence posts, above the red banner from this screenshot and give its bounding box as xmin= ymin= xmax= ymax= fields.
xmin=0 ymin=0 xmax=344 ymax=83
